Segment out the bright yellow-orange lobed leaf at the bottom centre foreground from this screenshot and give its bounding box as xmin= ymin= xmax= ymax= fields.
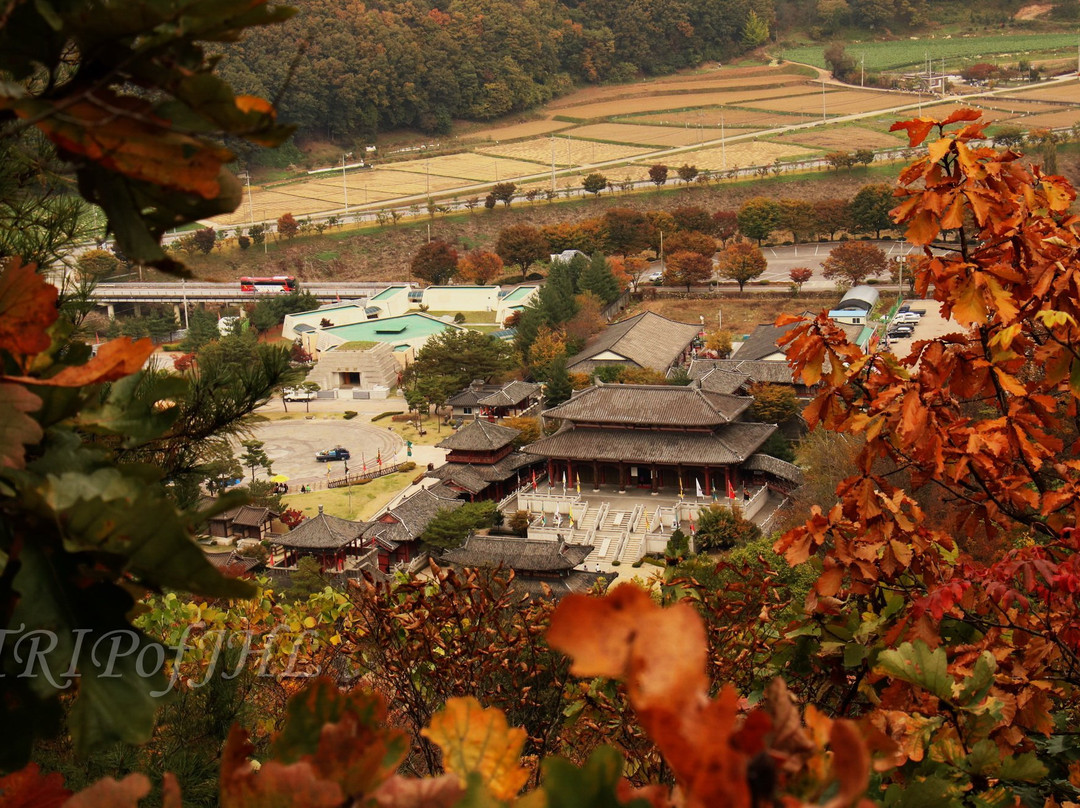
xmin=423 ymin=697 xmax=529 ymax=799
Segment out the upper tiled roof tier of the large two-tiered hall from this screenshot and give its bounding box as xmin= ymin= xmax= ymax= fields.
xmin=544 ymin=385 xmax=754 ymax=427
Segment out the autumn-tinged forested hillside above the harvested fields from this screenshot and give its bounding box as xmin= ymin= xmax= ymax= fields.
xmin=222 ymin=0 xmax=773 ymax=139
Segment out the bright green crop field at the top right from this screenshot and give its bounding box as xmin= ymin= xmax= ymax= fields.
xmin=781 ymin=32 xmax=1078 ymax=71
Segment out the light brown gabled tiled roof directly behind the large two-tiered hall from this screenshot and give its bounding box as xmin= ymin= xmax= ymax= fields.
xmin=566 ymin=311 xmax=701 ymax=373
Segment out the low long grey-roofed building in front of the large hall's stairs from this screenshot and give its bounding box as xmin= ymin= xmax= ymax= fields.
xmin=440 ymin=536 xmax=617 ymax=597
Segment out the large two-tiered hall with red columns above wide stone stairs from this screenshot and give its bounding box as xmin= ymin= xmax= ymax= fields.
xmin=524 ymin=385 xmax=777 ymax=498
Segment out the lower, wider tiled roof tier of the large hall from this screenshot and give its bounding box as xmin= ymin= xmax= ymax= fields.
xmin=525 ymin=421 xmax=777 ymax=466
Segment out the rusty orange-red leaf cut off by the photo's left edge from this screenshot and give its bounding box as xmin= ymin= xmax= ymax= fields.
xmin=0 ymin=264 xmax=59 ymax=356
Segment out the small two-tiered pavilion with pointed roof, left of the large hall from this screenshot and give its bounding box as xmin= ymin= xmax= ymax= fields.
xmin=428 ymin=419 xmax=539 ymax=502
